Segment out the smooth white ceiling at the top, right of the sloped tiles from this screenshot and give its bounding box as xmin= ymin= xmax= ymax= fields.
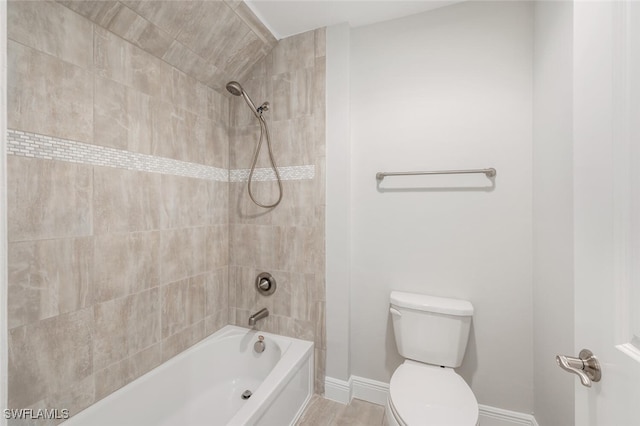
xmin=245 ymin=0 xmax=461 ymax=39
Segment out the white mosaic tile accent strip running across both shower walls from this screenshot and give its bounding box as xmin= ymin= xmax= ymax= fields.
xmin=7 ymin=129 xmax=315 ymax=182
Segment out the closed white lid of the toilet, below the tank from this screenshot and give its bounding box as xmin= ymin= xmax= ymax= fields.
xmin=389 ymin=360 xmax=478 ymax=426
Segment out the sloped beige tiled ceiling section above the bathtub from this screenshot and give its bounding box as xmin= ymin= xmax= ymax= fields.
xmin=68 ymin=0 xmax=277 ymax=93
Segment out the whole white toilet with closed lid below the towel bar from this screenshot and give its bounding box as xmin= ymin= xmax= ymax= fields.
xmin=385 ymin=291 xmax=478 ymax=426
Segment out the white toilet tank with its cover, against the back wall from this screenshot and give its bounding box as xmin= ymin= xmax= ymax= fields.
xmin=390 ymin=291 xmax=473 ymax=368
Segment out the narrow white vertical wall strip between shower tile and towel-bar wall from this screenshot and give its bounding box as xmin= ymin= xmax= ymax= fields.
xmin=326 ymin=23 xmax=351 ymax=381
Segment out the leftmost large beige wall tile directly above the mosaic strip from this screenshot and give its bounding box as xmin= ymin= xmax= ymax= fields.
xmin=7 ymin=40 xmax=93 ymax=142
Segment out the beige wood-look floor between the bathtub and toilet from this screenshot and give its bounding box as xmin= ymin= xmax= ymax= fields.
xmin=296 ymin=395 xmax=385 ymax=426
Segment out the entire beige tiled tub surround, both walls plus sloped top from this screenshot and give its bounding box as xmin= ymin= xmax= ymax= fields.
xmin=7 ymin=1 xmax=325 ymax=415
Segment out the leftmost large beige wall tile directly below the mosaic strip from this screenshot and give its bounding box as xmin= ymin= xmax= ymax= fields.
xmin=7 ymin=156 xmax=93 ymax=241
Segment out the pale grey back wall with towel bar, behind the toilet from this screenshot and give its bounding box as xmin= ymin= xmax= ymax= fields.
xmin=350 ymin=2 xmax=533 ymax=412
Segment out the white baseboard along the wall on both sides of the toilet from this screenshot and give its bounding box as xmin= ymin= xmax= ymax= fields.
xmin=324 ymin=376 xmax=538 ymax=426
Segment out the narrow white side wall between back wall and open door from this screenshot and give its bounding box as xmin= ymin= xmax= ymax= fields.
xmin=533 ymin=2 xmax=575 ymax=426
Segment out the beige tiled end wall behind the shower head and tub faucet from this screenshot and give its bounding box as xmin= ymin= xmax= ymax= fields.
xmin=229 ymin=29 xmax=326 ymax=393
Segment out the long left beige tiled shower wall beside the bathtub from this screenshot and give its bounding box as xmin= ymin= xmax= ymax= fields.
xmin=7 ymin=1 xmax=236 ymax=424
